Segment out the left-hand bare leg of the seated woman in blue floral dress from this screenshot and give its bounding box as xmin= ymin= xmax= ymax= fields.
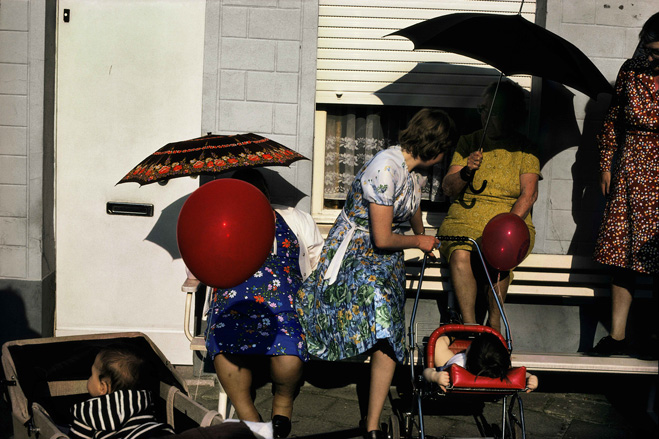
xmin=213 ymin=354 xmax=259 ymax=422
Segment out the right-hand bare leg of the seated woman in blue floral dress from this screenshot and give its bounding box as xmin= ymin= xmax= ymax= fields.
xmin=270 ymin=355 xmax=303 ymax=419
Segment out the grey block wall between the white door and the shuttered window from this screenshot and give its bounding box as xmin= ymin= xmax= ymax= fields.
xmin=202 ymin=0 xmax=318 ymax=210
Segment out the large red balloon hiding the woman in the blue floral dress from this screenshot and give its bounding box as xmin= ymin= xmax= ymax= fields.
xmin=176 ymin=178 xmax=275 ymax=288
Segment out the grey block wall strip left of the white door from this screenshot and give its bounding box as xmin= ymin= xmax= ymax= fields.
xmin=0 ymin=0 xmax=55 ymax=342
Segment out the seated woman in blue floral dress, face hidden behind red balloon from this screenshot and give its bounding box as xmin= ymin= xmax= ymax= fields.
xmin=206 ymin=169 xmax=323 ymax=438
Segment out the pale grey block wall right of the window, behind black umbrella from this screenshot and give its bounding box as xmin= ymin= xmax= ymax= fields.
xmin=534 ymin=0 xmax=659 ymax=255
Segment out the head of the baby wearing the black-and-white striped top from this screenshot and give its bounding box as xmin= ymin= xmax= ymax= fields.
xmin=87 ymin=347 xmax=146 ymax=397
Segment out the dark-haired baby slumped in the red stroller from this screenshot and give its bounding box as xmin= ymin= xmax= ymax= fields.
xmin=423 ymin=332 xmax=538 ymax=393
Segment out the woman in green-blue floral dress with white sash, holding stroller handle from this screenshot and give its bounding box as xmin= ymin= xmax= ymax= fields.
xmin=297 ymin=109 xmax=455 ymax=438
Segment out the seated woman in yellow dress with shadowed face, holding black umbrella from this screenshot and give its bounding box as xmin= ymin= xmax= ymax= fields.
xmin=439 ymin=80 xmax=542 ymax=331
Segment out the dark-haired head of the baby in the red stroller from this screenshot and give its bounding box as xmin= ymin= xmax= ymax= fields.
xmin=465 ymin=332 xmax=510 ymax=379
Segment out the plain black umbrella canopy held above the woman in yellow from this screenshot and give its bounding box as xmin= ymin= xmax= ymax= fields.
xmin=387 ymin=13 xmax=613 ymax=99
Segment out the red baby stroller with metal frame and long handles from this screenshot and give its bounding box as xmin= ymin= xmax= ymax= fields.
xmin=389 ymin=236 xmax=526 ymax=439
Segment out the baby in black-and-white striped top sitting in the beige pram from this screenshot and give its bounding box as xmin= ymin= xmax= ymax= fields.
xmin=69 ymin=346 xmax=256 ymax=439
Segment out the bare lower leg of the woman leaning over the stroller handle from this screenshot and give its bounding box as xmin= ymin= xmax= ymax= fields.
xmin=366 ymin=342 xmax=396 ymax=432
